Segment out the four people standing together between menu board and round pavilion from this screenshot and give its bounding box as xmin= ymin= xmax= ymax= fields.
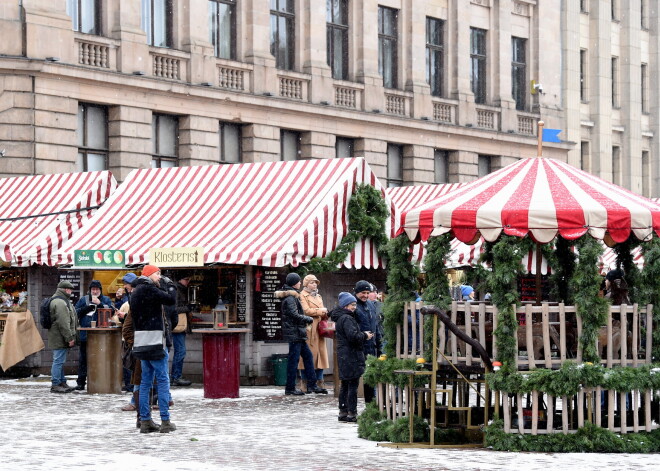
xmin=275 ymin=273 xmax=383 ymax=422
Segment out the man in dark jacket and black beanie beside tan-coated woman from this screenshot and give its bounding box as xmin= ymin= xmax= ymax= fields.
xmin=275 ymin=273 xmax=328 ymax=396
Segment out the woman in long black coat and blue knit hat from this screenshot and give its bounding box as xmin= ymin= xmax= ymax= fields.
xmin=330 ymin=292 xmax=374 ymax=422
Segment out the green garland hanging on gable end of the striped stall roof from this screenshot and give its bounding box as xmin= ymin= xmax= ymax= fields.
xmin=300 ymin=184 xmax=390 ymax=276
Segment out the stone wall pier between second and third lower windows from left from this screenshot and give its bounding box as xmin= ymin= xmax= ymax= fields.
xmin=179 ymin=116 xmax=220 ymax=167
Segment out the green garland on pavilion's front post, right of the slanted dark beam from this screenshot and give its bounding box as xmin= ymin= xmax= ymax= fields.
xmin=488 ymin=235 xmax=523 ymax=373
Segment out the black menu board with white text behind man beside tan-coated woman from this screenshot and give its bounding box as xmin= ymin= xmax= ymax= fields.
xmin=254 ymin=268 xmax=287 ymax=342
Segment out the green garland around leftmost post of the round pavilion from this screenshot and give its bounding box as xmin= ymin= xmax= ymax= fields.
xmin=383 ymin=234 xmax=419 ymax=357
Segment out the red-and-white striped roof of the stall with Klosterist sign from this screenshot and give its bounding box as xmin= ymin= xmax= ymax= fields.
xmin=62 ymin=158 xmax=395 ymax=268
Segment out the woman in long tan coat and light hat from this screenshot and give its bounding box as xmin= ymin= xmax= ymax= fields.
xmin=298 ymin=275 xmax=330 ymax=388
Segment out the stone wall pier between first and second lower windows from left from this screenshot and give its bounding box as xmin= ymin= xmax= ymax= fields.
xmin=108 ymin=106 xmax=153 ymax=182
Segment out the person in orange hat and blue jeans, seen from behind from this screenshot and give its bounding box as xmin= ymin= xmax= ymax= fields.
xmin=129 ymin=265 xmax=176 ymax=433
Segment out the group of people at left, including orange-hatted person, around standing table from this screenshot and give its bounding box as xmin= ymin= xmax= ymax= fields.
xmin=48 ymin=265 xmax=191 ymax=433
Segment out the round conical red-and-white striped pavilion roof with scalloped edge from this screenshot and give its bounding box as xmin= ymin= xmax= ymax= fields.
xmin=401 ymin=157 xmax=660 ymax=247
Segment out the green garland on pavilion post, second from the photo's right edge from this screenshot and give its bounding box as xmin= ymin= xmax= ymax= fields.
xmin=569 ymin=235 xmax=609 ymax=363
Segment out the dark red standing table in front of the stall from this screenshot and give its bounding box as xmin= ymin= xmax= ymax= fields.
xmin=192 ymin=329 xmax=250 ymax=399
